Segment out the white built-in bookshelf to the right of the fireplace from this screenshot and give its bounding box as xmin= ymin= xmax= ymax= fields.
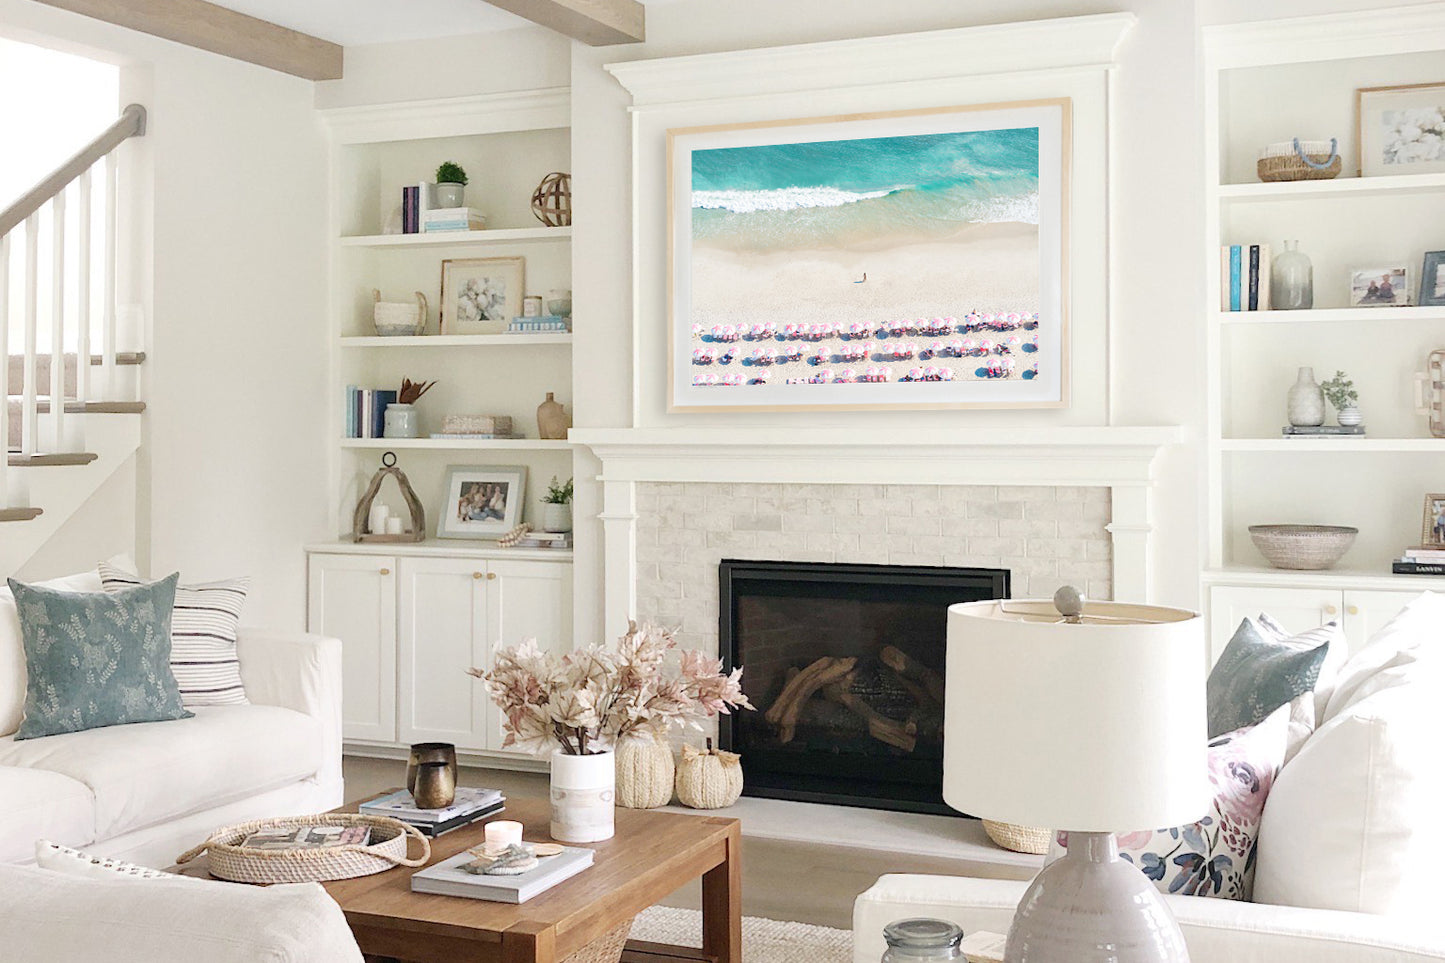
xmin=1201 ymin=4 xmax=1445 ymax=649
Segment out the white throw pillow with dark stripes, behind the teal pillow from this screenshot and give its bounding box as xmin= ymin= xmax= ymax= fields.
xmin=100 ymin=562 xmax=251 ymax=709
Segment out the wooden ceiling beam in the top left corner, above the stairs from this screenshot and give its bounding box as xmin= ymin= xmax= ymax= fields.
xmin=29 ymin=0 xmax=342 ymax=81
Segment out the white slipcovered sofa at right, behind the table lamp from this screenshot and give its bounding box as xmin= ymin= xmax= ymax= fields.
xmin=853 ymin=594 xmax=1445 ymax=963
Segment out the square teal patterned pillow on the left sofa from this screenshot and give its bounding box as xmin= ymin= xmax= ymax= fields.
xmin=9 ymin=575 xmax=194 ymax=739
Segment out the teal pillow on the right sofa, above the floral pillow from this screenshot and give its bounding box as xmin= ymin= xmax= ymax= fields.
xmin=1207 ymin=619 xmax=1338 ymax=739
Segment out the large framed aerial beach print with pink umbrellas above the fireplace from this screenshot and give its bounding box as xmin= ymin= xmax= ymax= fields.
xmin=668 ymin=98 xmax=1071 ymax=411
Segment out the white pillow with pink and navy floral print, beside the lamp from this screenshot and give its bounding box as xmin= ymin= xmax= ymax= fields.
xmin=1117 ymin=704 xmax=1289 ymax=901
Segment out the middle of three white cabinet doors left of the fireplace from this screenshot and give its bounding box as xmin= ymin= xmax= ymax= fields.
xmin=397 ymin=558 xmax=500 ymax=749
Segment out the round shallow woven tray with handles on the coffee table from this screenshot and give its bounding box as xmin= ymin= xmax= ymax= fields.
xmin=176 ymin=813 xmax=432 ymax=883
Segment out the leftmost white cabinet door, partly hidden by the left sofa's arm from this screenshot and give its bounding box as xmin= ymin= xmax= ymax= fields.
xmin=306 ymin=554 xmax=396 ymax=742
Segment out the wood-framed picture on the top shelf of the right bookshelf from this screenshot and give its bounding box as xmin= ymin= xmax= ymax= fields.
xmin=1355 ymin=84 xmax=1445 ymax=178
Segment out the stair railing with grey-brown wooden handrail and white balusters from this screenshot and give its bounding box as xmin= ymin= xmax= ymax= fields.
xmin=0 ymin=104 xmax=146 ymax=521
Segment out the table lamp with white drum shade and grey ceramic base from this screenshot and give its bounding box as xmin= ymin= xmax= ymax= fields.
xmin=944 ymin=589 xmax=1211 ymax=963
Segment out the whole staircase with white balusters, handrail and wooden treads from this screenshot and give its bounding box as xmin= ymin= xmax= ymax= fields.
xmin=0 ymin=104 xmax=146 ymax=574
